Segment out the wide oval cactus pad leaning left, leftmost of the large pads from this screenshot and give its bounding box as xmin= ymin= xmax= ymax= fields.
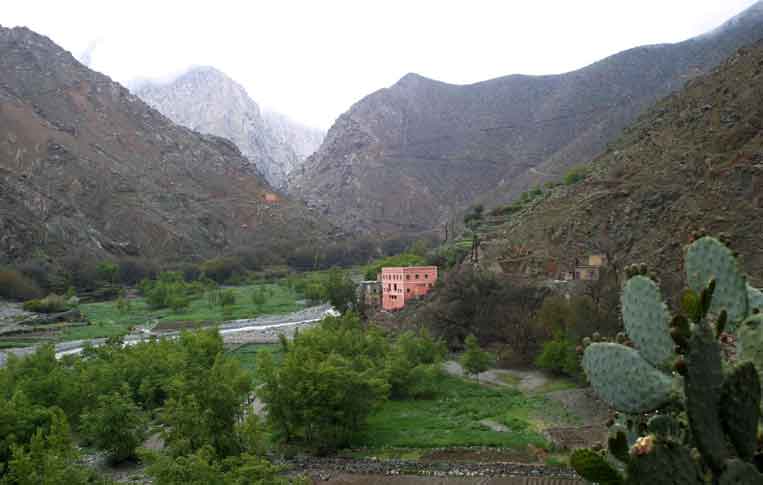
xmin=583 ymin=343 xmax=673 ymax=413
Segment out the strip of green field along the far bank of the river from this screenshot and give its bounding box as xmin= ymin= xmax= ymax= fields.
xmin=60 ymin=284 xmax=303 ymax=341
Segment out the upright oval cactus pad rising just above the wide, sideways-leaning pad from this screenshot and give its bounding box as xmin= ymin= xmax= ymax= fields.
xmin=621 ymin=276 xmax=675 ymax=368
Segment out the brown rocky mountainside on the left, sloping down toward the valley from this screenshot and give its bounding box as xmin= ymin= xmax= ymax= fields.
xmin=0 ymin=27 xmax=321 ymax=262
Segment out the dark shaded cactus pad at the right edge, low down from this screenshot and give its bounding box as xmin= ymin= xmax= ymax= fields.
xmin=721 ymin=362 xmax=760 ymax=461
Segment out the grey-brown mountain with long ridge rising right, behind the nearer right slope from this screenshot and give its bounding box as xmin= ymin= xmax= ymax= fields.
xmin=289 ymin=2 xmax=763 ymax=236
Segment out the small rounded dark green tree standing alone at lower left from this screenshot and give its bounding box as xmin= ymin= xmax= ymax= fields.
xmin=81 ymin=384 xmax=148 ymax=463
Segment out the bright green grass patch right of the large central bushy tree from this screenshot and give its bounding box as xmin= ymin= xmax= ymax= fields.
xmin=358 ymin=375 xmax=548 ymax=449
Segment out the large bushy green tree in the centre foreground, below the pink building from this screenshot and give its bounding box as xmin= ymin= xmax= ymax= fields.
xmin=257 ymin=313 xmax=389 ymax=452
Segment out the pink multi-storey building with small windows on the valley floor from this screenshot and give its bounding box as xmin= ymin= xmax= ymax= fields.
xmin=379 ymin=266 xmax=437 ymax=310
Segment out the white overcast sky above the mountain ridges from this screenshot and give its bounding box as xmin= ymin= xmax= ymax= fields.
xmin=0 ymin=0 xmax=755 ymax=128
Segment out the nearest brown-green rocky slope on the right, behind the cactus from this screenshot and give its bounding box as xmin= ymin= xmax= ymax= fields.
xmin=482 ymin=42 xmax=763 ymax=294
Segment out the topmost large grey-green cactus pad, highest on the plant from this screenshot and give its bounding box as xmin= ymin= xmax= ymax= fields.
xmin=685 ymin=237 xmax=747 ymax=323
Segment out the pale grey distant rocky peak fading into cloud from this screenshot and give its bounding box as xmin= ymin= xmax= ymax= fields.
xmin=134 ymin=67 xmax=323 ymax=188
